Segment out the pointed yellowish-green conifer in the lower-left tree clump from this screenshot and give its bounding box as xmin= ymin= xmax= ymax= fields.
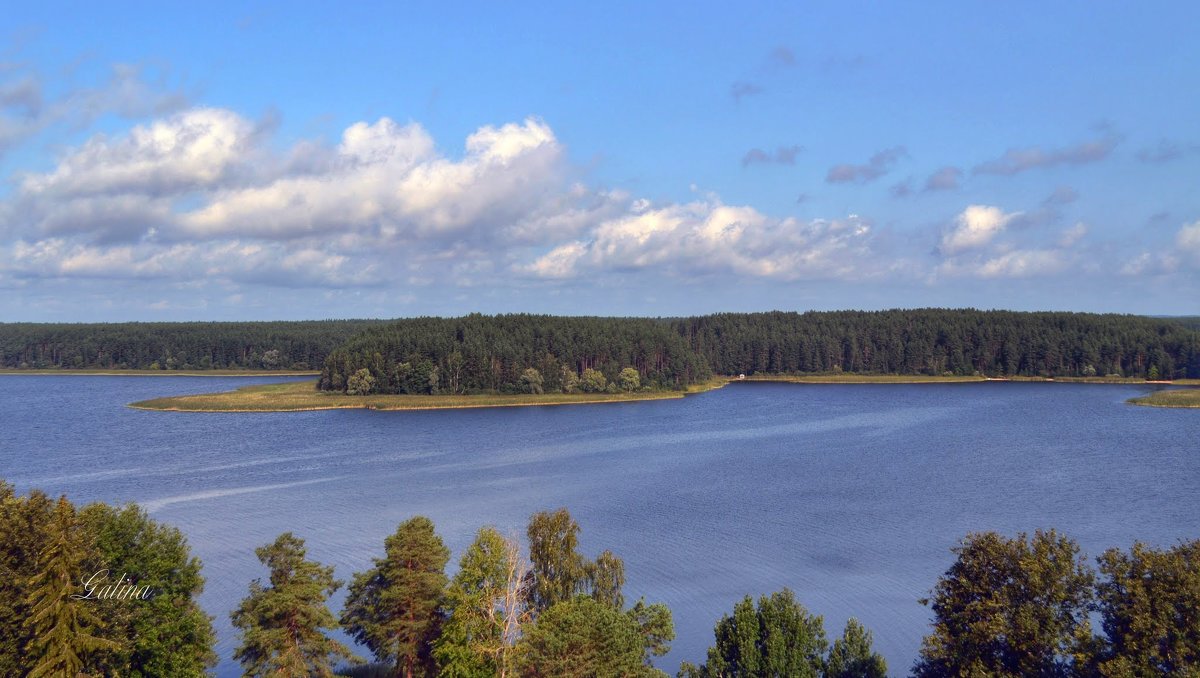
xmin=25 ymin=497 xmax=120 ymax=678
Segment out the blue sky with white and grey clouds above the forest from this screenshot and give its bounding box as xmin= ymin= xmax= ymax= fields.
xmin=0 ymin=1 xmax=1200 ymax=322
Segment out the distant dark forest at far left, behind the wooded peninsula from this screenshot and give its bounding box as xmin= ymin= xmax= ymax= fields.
xmin=0 ymin=320 xmax=380 ymax=370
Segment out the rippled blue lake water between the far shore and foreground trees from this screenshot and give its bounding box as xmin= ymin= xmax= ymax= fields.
xmin=0 ymin=376 xmax=1200 ymax=676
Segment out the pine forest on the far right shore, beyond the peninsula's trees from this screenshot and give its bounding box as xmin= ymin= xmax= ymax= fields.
xmin=673 ymin=308 xmax=1200 ymax=378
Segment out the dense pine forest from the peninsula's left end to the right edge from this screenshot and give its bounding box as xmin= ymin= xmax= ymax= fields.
xmin=319 ymin=308 xmax=1200 ymax=394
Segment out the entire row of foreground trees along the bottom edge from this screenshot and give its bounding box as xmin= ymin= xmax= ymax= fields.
xmin=0 ymin=482 xmax=1200 ymax=678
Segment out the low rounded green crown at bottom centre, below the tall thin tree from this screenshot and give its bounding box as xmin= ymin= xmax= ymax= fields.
xmin=517 ymin=596 xmax=664 ymax=678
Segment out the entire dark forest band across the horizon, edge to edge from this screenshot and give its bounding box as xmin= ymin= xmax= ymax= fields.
xmin=0 ymin=308 xmax=1200 ymax=394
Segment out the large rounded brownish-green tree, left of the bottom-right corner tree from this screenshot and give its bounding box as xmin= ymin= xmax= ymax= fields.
xmin=914 ymin=530 xmax=1094 ymax=677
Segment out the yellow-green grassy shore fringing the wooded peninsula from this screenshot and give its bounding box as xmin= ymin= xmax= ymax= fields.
xmin=130 ymin=379 xmax=727 ymax=412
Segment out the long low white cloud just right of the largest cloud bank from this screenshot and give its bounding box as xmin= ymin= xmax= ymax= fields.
xmin=518 ymin=199 xmax=883 ymax=281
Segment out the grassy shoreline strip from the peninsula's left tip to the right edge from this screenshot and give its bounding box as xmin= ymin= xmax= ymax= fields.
xmin=121 ymin=374 xmax=1200 ymax=413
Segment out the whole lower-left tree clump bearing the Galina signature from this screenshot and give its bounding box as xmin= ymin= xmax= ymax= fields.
xmin=0 ymin=481 xmax=216 ymax=677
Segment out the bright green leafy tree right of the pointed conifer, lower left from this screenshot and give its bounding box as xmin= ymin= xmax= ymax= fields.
xmin=79 ymin=504 xmax=217 ymax=678
